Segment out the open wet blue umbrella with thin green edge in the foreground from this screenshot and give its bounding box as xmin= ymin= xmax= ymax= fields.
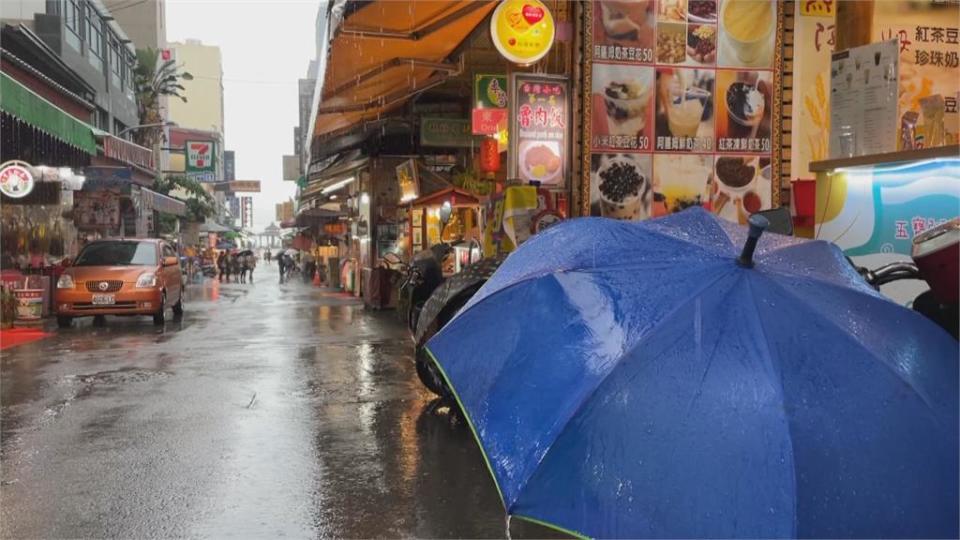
xmin=428 ymin=208 xmax=960 ymax=538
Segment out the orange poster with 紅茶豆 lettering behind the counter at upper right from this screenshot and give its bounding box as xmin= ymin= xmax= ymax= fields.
xmin=872 ymin=1 xmax=960 ymax=146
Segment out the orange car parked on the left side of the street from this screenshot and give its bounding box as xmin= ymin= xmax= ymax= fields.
xmin=55 ymin=239 xmax=183 ymax=328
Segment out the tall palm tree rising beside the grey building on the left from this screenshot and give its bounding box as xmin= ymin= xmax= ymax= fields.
xmin=133 ymin=48 xmax=193 ymax=148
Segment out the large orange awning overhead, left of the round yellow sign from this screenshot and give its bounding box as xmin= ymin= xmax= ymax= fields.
xmin=313 ymin=0 xmax=496 ymax=140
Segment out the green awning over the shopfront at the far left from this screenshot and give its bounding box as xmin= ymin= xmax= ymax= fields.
xmin=0 ymin=73 xmax=97 ymax=156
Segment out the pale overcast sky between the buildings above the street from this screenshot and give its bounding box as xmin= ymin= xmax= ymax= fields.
xmin=167 ymin=0 xmax=319 ymax=229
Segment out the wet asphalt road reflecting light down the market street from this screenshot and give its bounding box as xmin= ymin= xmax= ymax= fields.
xmin=0 ymin=265 xmax=549 ymax=538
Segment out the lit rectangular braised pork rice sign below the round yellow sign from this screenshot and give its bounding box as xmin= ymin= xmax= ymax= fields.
xmin=509 ymin=73 xmax=570 ymax=188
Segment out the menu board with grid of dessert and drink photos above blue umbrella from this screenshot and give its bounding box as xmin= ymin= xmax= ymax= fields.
xmin=584 ymin=0 xmax=780 ymax=223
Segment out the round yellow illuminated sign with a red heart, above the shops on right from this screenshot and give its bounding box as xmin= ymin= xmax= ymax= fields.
xmin=490 ymin=0 xmax=556 ymax=65
